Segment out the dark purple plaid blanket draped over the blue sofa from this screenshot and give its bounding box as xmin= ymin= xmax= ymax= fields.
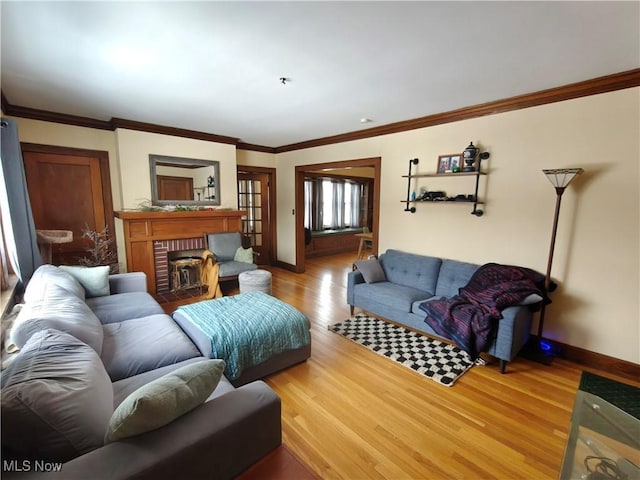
xmin=420 ymin=263 xmax=548 ymax=359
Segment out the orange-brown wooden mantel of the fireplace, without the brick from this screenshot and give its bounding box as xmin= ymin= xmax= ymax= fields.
xmin=115 ymin=210 xmax=247 ymax=293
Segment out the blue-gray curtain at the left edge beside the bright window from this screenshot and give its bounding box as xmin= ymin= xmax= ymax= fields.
xmin=0 ymin=118 xmax=42 ymax=284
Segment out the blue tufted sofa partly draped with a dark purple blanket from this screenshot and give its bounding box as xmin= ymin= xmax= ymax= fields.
xmin=347 ymin=250 xmax=543 ymax=373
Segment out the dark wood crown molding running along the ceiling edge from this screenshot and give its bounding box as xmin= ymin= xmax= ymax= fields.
xmin=1 ymin=68 xmax=640 ymax=153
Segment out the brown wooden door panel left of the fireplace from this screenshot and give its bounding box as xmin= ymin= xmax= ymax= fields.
xmin=22 ymin=143 xmax=115 ymax=265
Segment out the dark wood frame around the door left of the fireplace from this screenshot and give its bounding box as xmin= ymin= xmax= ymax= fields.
xmin=20 ymin=142 xmax=120 ymax=264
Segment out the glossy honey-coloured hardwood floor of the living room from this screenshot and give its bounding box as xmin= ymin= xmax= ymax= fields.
xmin=178 ymin=254 xmax=631 ymax=479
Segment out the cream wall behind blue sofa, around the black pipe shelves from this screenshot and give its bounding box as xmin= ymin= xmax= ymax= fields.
xmin=276 ymin=88 xmax=640 ymax=363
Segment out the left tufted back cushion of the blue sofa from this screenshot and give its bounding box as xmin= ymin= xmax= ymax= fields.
xmin=380 ymin=250 xmax=442 ymax=294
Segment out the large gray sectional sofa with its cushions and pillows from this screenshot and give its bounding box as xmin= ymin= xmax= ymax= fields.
xmin=1 ymin=265 xmax=281 ymax=480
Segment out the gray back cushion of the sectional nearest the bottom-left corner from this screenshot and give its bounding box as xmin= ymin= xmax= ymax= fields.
xmin=1 ymin=329 xmax=113 ymax=462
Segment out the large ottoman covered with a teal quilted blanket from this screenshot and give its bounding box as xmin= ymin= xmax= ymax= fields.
xmin=173 ymin=291 xmax=311 ymax=387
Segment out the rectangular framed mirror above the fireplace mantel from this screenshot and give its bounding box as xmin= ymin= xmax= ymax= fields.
xmin=149 ymin=154 xmax=220 ymax=205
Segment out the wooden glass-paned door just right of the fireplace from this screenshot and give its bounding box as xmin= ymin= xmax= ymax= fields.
xmin=238 ymin=167 xmax=275 ymax=265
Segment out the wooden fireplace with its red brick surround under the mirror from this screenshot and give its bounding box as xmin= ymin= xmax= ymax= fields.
xmin=115 ymin=210 xmax=246 ymax=294
